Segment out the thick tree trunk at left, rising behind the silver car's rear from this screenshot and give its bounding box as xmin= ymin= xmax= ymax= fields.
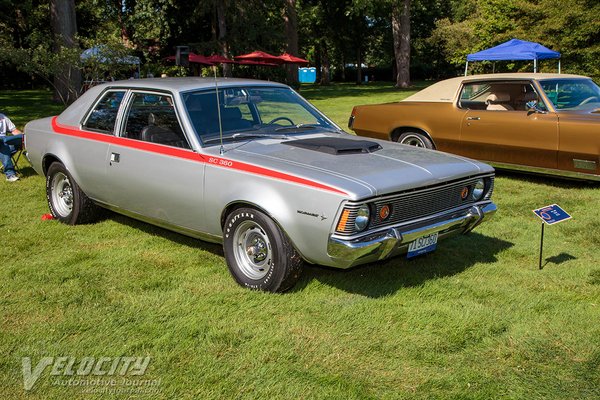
xmin=50 ymin=0 xmax=81 ymax=104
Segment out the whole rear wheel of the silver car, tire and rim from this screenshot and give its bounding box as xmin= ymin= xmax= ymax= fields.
xmin=46 ymin=162 xmax=100 ymax=225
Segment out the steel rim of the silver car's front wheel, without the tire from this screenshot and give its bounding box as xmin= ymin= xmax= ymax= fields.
xmin=233 ymin=221 xmax=273 ymax=280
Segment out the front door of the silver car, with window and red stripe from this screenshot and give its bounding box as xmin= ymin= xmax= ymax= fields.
xmin=106 ymin=91 xmax=204 ymax=231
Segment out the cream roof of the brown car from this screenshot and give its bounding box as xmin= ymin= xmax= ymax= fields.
xmin=403 ymin=72 xmax=590 ymax=103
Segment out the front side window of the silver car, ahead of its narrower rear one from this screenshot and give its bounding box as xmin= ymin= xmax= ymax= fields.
xmin=123 ymin=93 xmax=190 ymax=149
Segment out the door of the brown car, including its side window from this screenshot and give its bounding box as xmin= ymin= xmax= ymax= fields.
xmin=459 ymin=81 xmax=558 ymax=168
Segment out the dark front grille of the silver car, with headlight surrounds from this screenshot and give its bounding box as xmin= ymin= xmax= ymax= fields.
xmin=338 ymin=177 xmax=494 ymax=235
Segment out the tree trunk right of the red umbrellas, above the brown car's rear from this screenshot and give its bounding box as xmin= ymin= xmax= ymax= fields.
xmin=392 ymin=0 xmax=410 ymax=88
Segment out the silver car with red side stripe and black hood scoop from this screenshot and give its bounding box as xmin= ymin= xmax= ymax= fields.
xmin=25 ymin=78 xmax=496 ymax=292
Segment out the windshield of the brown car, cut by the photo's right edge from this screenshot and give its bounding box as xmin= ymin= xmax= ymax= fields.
xmin=540 ymin=79 xmax=600 ymax=110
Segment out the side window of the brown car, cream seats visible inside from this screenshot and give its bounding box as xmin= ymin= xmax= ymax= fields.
xmin=459 ymin=82 xmax=543 ymax=111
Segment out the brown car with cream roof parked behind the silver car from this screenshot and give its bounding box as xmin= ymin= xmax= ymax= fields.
xmin=348 ymin=73 xmax=600 ymax=180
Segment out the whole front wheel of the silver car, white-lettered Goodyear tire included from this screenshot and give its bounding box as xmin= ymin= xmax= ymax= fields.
xmin=223 ymin=208 xmax=303 ymax=292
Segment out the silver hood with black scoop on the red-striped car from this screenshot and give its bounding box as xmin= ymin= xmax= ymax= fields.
xmin=219 ymin=134 xmax=493 ymax=200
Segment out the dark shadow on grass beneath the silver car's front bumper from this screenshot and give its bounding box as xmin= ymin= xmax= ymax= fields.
xmin=292 ymin=233 xmax=513 ymax=298
